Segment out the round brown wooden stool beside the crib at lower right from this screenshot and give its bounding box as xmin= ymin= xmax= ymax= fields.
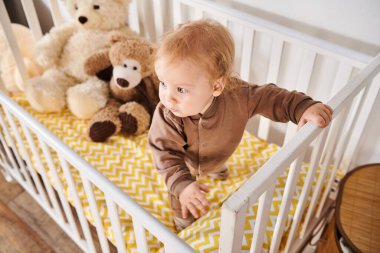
xmin=335 ymin=164 xmax=380 ymax=252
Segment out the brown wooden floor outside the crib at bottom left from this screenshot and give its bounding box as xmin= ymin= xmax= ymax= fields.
xmin=0 ymin=173 xmax=82 ymax=253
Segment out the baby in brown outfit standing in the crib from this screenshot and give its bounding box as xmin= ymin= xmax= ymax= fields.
xmin=149 ymin=20 xmax=332 ymax=232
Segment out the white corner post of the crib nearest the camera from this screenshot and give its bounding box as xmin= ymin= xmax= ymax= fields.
xmin=219 ymin=199 xmax=248 ymax=253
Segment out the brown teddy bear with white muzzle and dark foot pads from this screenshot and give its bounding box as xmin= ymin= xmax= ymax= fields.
xmin=85 ymin=32 xmax=159 ymax=142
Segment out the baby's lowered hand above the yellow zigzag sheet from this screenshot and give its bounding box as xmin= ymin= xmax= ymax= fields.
xmin=179 ymin=182 xmax=210 ymax=219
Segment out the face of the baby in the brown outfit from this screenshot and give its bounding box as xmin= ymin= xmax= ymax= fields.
xmin=155 ymin=58 xmax=215 ymax=117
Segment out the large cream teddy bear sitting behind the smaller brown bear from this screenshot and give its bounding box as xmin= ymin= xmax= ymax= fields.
xmin=25 ymin=0 xmax=137 ymax=118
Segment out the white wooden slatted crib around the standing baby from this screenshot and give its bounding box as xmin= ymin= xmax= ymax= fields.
xmin=0 ymin=0 xmax=380 ymax=252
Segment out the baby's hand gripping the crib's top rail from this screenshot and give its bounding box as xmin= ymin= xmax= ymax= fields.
xmin=298 ymin=103 xmax=333 ymax=128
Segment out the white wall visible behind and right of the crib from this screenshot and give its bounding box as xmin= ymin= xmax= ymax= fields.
xmin=220 ymin=0 xmax=380 ymax=165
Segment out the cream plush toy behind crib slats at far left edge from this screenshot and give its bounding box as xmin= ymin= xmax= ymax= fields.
xmin=0 ymin=24 xmax=43 ymax=93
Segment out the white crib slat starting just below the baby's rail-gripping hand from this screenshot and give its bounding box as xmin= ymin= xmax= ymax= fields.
xmin=284 ymin=126 xmax=330 ymax=252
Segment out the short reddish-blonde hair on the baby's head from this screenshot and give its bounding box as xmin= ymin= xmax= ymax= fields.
xmin=156 ymin=19 xmax=235 ymax=88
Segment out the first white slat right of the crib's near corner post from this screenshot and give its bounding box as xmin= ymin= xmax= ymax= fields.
xmin=250 ymin=184 xmax=275 ymax=253
